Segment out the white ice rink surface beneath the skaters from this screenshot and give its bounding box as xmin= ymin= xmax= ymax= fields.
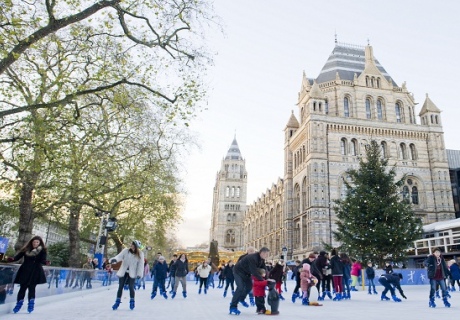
xmin=0 ymin=281 xmax=460 ymax=320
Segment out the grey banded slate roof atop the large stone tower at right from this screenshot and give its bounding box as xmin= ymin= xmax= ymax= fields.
xmin=316 ymin=42 xmax=398 ymax=87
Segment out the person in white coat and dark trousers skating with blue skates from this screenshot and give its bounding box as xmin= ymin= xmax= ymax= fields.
xmin=110 ymin=240 xmax=144 ymax=310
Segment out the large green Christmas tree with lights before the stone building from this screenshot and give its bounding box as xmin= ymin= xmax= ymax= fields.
xmin=333 ymin=140 xmax=422 ymax=266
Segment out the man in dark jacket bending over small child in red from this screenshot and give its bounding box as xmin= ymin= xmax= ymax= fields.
xmin=230 ymin=247 xmax=270 ymax=314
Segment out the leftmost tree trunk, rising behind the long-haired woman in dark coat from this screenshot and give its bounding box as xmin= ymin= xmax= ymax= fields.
xmin=14 ymin=175 xmax=37 ymax=252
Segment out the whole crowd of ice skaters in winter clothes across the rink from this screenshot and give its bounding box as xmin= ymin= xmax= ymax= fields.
xmin=1 ymin=236 xmax=460 ymax=315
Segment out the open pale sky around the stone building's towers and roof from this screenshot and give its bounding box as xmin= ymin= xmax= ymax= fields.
xmin=177 ymin=0 xmax=460 ymax=246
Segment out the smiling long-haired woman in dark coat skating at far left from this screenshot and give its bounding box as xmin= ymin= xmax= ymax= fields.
xmin=10 ymin=236 xmax=46 ymax=313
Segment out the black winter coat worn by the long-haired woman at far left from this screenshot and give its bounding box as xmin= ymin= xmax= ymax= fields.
xmin=13 ymin=247 xmax=46 ymax=286
